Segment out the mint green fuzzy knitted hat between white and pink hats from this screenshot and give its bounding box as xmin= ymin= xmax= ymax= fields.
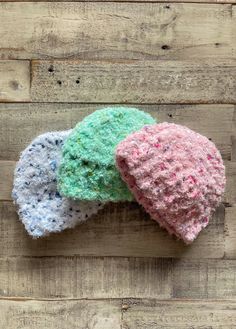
xmin=58 ymin=107 xmax=155 ymax=201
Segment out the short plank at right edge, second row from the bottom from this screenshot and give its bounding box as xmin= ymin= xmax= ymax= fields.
xmin=172 ymin=259 xmax=236 ymax=300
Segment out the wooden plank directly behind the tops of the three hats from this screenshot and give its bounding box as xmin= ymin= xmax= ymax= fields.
xmin=0 ymin=103 xmax=234 ymax=160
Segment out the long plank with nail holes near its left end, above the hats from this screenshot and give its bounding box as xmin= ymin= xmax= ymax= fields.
xmin=31 ymin=60 xmax=236 ymax=103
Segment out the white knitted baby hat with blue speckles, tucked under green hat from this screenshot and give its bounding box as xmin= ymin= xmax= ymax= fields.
xmin=12 ymin=131 xmax=103 ymax=238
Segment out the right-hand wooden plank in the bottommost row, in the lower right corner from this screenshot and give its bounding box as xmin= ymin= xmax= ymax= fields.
xmin=123 ymin=300 xmax=236 ymax=329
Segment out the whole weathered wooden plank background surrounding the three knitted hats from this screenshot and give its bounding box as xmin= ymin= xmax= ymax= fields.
xmin=0 ymin=0 xmax=236 ymax=329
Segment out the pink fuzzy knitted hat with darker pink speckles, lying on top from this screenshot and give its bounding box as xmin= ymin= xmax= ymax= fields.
xmin=116 ymin=123 xmax=225 ymax=243
